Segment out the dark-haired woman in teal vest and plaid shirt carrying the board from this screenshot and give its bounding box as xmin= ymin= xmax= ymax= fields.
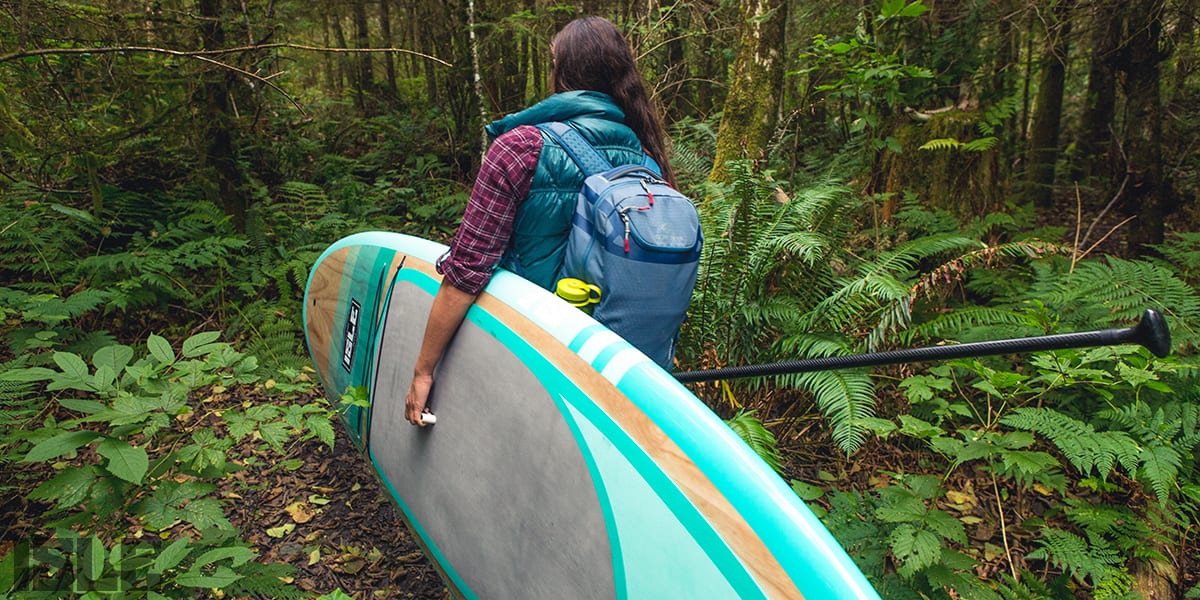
xmin=404 ymin=17 xmax=674 ymax=426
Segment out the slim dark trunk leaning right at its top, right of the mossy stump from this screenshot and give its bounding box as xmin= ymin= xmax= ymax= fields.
xmin=1025 ymin=2 xmax=1073 ymax=211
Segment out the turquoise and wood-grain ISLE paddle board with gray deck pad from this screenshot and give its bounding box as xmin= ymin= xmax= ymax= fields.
xmin=305 ymin=232 xmax=878 ymax=600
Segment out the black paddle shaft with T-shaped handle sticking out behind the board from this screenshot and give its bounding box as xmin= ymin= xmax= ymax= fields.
xmin=673 ymin=308 xmax=1171 ymax=383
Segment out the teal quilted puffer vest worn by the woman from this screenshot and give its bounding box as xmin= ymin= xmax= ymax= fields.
xmin=487 ymin=91 xmax=642 ymax=289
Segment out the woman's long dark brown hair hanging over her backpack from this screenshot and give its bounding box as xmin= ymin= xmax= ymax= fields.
xmin=550 ymin=17 xmax=674 ymax=185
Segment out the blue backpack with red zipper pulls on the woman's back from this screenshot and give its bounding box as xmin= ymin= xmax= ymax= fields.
xmin=538 ymin=122 xmax=703 ymax=371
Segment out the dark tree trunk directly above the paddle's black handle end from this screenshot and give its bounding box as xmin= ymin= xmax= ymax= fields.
xmin=1122 ymin=0 xmax=1168 ymax=256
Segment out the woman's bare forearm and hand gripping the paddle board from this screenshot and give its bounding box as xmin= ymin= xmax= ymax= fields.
xmin=404 ymin=280 xmax=479 ymax=427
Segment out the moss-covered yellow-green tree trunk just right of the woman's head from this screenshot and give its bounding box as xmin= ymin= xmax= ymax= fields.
xmin=708 ymin=0 xmax=787 ymax=181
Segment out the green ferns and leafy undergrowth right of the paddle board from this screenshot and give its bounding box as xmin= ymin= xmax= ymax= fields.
xmin=679 ymin=160 xmax=1200 ymax=599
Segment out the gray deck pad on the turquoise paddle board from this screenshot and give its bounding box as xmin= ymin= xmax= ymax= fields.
xmin=368 ymin=281 xmax=616 ymax=599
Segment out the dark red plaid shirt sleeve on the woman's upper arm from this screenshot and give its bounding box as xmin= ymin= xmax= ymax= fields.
xmin=438 ymin=126 xmax=541 ymax=294
